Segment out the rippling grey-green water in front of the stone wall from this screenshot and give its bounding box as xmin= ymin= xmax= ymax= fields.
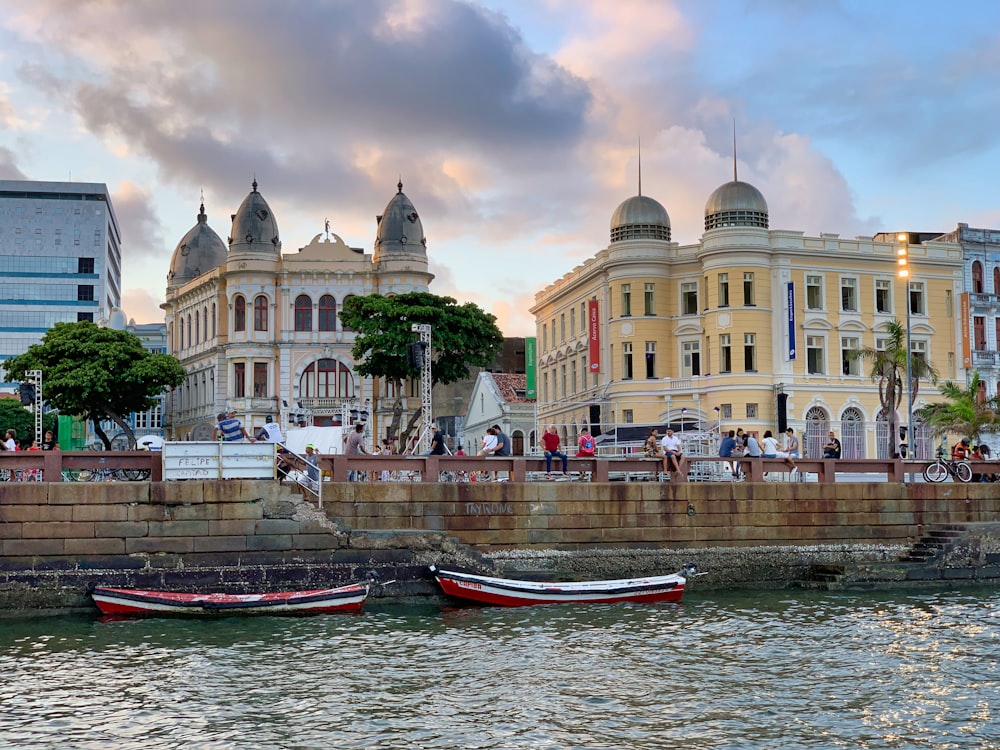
xmin=0 ymin=589 xmax=1000 ymax=750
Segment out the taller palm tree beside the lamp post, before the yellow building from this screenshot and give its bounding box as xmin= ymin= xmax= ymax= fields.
xmin=852 ymin=318 xmax=938 ymax=456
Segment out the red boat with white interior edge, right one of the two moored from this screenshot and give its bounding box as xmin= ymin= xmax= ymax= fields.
xmin=430 ymin=563 xmax=697 ymax=607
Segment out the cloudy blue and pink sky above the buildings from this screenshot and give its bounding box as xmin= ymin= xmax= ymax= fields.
xmin=0 ymin=0 xmax=1000 ymax=336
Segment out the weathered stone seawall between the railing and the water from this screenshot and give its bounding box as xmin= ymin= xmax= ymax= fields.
xmin=0 ymin=481 xmax=1000 ymax=614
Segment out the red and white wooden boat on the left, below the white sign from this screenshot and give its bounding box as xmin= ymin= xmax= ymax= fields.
xmin=90 ymin=583 xmax=369 ymax=616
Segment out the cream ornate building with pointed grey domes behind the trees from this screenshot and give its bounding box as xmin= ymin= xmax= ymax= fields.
xmin=163 ymin=181 xmax=433 ymax=440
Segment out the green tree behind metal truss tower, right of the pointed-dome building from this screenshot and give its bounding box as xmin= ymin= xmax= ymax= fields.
xmin=340 ymin=292 xmax=503 ymax=444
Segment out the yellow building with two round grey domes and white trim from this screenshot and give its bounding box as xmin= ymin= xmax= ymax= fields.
xmin=532 ymin=174 xmax=963 ymax=457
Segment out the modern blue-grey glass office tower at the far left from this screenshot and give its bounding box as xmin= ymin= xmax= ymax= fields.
xmin=0 ymin=180 xmax=122 ymax=370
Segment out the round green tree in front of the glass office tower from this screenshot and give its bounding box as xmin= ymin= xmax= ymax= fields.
xmin=3 ymin=321 xmax=186 ymax=450
